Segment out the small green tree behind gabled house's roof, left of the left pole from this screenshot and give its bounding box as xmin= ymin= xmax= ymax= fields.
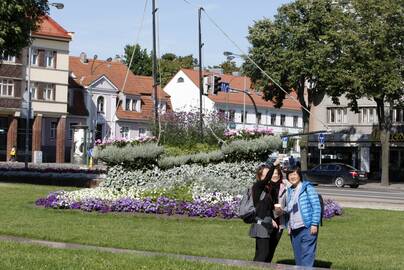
xmin=124 ymin=44 xmax=152 ymax=76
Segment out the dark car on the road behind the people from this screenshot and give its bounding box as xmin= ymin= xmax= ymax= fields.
xmin=302 ymin=163 xmax=367 ymax=188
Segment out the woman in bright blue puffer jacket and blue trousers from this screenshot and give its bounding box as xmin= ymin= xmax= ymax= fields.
xmin=287 ymin=167 xmax=321 ymax=266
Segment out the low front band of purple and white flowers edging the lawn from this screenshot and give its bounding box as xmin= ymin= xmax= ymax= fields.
xmin=36 ymin=188 xmax=342 ymax=219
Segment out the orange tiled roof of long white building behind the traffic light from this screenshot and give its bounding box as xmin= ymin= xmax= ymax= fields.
xmin=181 ymin=69 xmax=301 ymax=111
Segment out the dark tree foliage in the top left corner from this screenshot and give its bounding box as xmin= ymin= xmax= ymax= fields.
xmin=0 ymin=0 xmax=49 ymax=55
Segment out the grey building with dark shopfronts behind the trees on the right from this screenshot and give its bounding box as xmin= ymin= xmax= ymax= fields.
xmin=309 ymin=96 xmax=404 ymax=180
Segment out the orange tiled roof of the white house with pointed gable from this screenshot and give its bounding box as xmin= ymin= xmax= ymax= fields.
xmin=69 ymin=56 xmax=171 ymax=120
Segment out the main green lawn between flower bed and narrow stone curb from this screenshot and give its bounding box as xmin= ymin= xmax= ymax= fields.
xmin=0 ymin=184 xmax=404 ymax=269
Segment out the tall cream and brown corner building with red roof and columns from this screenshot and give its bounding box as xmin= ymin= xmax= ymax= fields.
xmin=0 ymin=16 xmax=71 ymax=162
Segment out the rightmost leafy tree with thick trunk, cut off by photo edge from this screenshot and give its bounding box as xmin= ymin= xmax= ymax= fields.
xmin=342 ymin=0 xmax=404 ymax=185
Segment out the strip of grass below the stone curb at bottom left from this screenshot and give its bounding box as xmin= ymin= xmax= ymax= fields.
xmin=0 ymin=242 xmax=256 ymax=270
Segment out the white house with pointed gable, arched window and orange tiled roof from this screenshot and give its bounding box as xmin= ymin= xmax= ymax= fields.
xmin=69 ymin=53 xmax=171 ymax=141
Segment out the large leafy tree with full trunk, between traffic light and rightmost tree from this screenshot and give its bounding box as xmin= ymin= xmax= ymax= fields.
xmin=244 ymin=0 xmax=348 ymax=170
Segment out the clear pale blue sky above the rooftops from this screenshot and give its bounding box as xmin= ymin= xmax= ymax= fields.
xmin=50 ymin=0 xmax=291 ymax=66
